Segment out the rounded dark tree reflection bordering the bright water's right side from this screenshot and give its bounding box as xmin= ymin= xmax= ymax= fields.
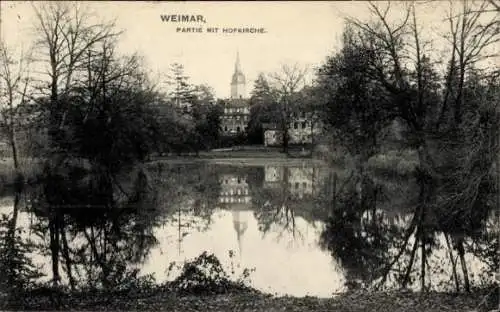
xmin=320 ymin=171 xmax=401 ymax=288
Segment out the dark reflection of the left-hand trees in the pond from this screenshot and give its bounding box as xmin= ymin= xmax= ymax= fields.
xmin=27 ymin=161 xmax=164 ymax=288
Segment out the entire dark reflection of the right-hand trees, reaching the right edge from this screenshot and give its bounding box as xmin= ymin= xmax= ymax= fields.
xmin=321 ymin=163 xmax=498 ymax=291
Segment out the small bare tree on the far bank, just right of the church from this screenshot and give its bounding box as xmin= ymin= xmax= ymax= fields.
xmin=269 ymin=64 xmax=308 ymax=153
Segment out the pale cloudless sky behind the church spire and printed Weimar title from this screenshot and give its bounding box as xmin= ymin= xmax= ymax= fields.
xmin=0 ymin=1 xmax=492 ymax=98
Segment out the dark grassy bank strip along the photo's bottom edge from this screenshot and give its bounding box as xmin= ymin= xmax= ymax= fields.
xmin=4 ymin=291 xmax=494 ymax=312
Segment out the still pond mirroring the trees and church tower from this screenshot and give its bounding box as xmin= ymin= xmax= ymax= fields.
xmin=0 ymin=160 xmax=493 ymax=297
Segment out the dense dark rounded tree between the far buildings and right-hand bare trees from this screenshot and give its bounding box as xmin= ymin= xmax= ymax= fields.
xmin=318 ymin=27 xmax=394 ymax=162
